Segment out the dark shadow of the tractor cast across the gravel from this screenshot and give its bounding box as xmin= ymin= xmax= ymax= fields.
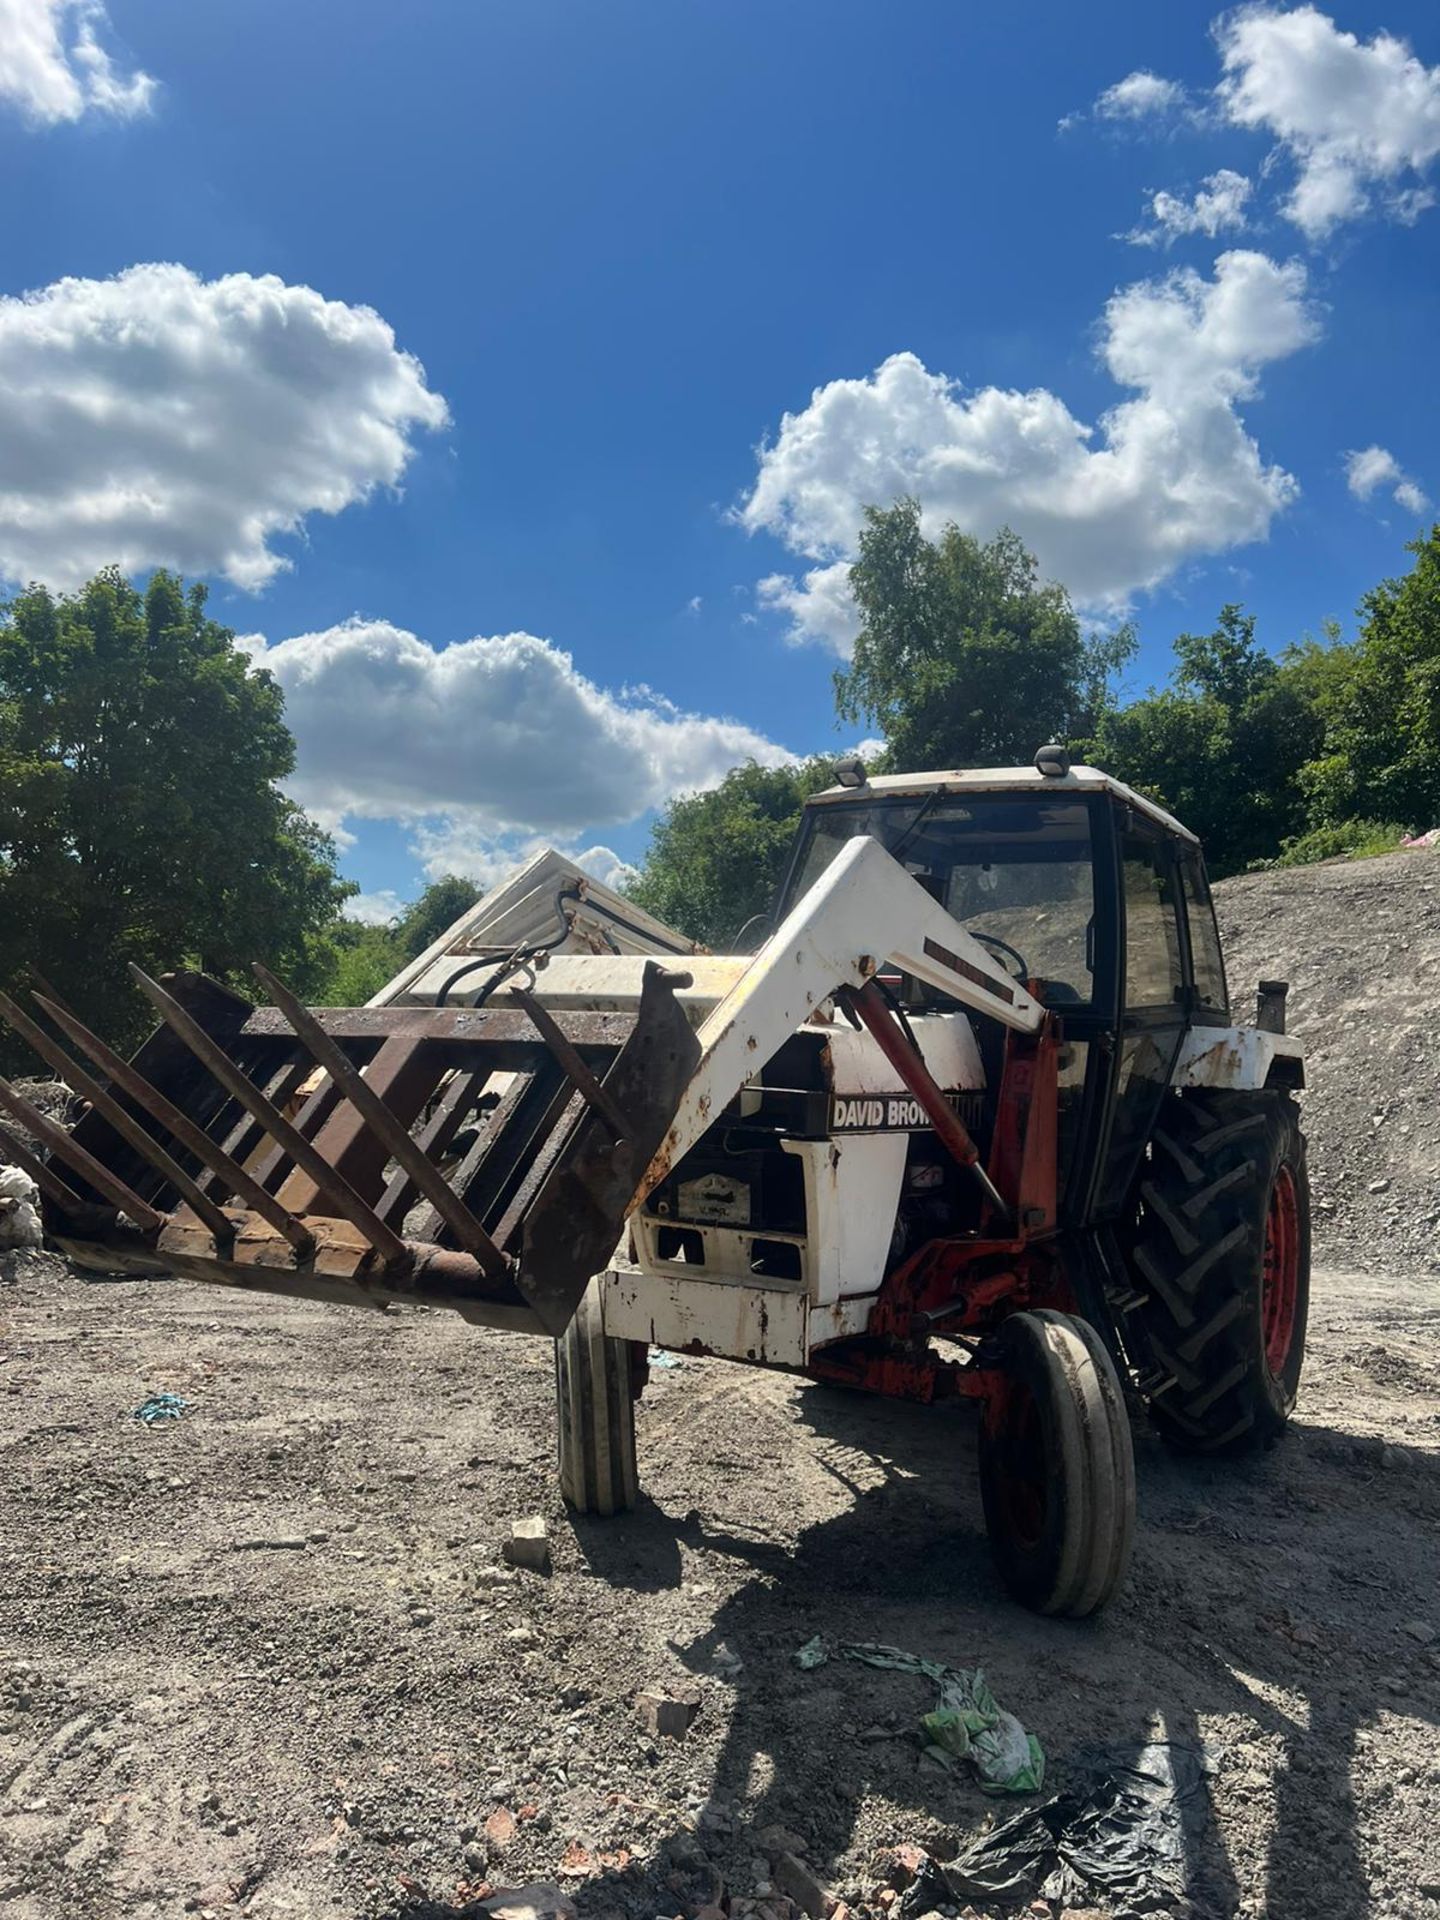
xmin=576 ymin=1386 xmax=1440 ymax=1920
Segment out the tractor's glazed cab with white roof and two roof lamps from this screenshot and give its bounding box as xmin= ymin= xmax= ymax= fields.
xmin=778 ymin=749 xmax=1231 ymax=1219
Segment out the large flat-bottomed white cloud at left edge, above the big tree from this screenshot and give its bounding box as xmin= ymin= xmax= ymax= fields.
xmin=0 ymin=263 xmax=447 ymax=589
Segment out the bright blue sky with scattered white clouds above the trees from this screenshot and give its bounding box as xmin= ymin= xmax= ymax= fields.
xmin=0 ymin=0 xmax=1440 ymax=913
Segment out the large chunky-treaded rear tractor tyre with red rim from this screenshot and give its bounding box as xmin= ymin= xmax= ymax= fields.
xmin=1119 ymin=1091 xmax=1309 ymax=1453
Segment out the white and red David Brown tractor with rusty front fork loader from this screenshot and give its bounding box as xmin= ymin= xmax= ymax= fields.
xmin=0 ymin=749 xmax=1309 ymax=1617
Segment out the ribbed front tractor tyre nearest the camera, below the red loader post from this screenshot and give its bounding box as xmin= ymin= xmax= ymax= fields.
xmin=979 ymin=1308 xmax=1135 ymax=1620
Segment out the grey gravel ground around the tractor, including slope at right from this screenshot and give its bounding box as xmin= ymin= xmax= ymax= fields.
xmin=0 ymin=854 xmax=1440 ymax=1920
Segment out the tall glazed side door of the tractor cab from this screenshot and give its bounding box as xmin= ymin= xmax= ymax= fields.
xmin=1094 ymin=808 xmax=1188 ymax=1219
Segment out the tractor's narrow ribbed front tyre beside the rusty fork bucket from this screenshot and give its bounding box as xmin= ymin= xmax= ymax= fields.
xmin=555 ymin=1279 xmax=639 ymax=1515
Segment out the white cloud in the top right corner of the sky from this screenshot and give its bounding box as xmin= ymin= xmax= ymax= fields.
xmin=1215 ymin=6 xmax=1440 ymax=240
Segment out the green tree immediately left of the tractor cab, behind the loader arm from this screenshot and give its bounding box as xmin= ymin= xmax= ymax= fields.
xmin=626 ymin=758 xmax=835 ymax=952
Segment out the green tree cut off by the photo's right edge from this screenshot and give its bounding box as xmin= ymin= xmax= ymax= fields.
xmin=1300 ymin=526 xmax=1440 ymax=831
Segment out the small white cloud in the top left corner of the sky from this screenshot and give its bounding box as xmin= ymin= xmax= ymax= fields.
xmin=0 ymin=0 xmax=156 ymax=127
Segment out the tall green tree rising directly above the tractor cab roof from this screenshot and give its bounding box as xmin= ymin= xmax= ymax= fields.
xmin=835 ymin=499 xmax=1135 ymax=772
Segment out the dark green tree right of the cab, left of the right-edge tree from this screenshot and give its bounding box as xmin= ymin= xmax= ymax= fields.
xmin=1085 ymin=605 xmax=1319 ymax=874
